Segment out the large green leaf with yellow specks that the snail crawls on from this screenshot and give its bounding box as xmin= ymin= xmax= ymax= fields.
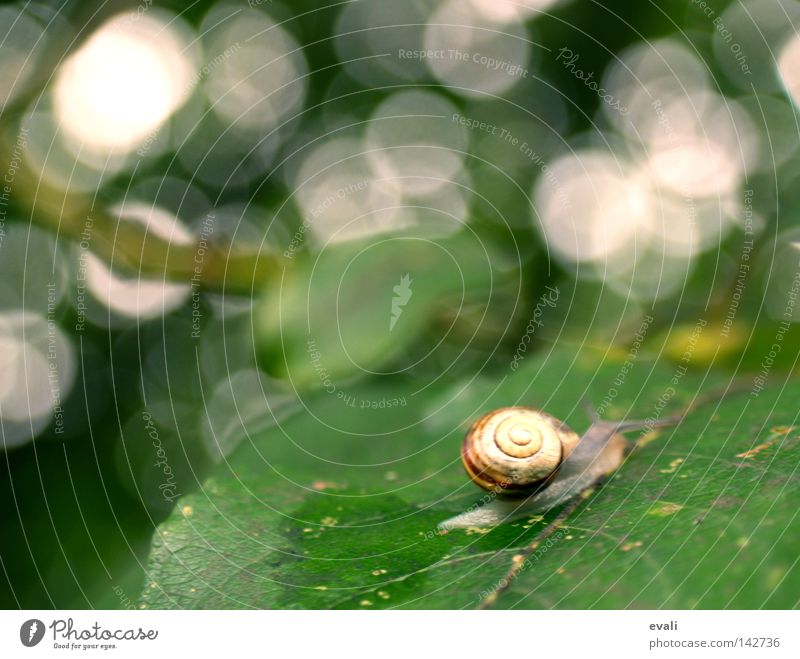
xmin=140 ymin=351 xmax=800 ymax=608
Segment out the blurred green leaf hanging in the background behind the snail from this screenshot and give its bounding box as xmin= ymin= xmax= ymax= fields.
xmin=255 ymin=232 xmax=510 ymax=389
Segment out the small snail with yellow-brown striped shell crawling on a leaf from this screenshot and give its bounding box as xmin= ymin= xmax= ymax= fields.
xmin=439 ymin=407 xmax=682 ymax=530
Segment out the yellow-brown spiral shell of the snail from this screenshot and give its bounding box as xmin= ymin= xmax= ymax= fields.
xmin=461 ymin=407 xmax=580 ymax=495
